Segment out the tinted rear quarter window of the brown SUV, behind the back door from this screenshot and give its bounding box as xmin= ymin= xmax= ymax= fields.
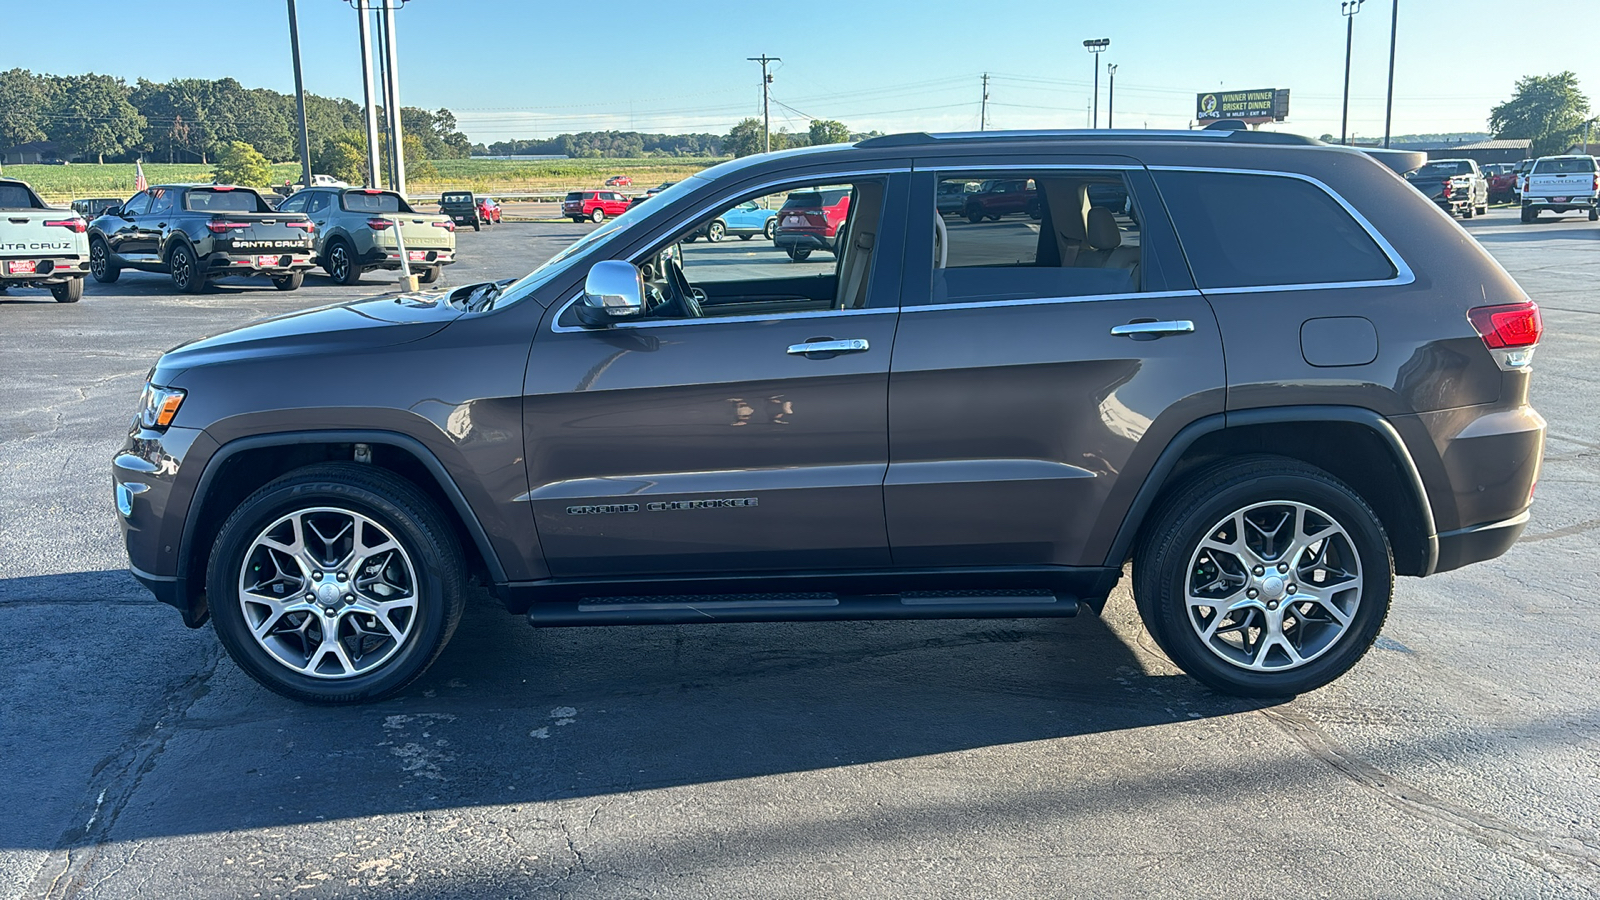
xmin=1155 ymin=171 xmax=1397 ymax=288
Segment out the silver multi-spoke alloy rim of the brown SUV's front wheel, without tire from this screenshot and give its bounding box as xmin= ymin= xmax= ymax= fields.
xmin=238 ymin=506 xmax=418 ymax=679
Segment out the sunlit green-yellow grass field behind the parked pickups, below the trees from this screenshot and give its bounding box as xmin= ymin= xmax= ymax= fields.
xmin=5 ymin=157 xmax=723 ymax=203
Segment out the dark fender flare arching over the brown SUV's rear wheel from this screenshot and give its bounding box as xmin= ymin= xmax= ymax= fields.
xmin=1106 ymin=405 xmax=1438 ymax=575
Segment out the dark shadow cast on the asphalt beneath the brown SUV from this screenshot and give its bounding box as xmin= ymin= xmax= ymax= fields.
xmin=0 ymin=572 xmax=1267 ymax=849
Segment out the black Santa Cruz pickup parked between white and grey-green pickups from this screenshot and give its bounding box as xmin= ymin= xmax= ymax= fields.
xmin=90 ymin=184 xmax=314 ymax=293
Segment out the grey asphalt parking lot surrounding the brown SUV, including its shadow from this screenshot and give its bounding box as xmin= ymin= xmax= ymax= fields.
xmin=0 ymin=210 xmax=1600 ymax=900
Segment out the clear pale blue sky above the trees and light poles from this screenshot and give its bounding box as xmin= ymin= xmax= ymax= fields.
xmin=0 ymin=0 xmax=1600 ymax=143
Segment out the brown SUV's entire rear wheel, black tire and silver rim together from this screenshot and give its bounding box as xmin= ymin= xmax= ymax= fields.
xmin=1133 ymin=456 xmax=1394 ymax=697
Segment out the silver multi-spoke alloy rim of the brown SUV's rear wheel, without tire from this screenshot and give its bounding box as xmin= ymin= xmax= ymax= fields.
xmin=1184 ymin=500 xmax=1362 ymax=673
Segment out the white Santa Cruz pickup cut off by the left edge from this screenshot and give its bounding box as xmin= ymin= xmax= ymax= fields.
xmin=0 ymin=178 xmax=90 ymax=303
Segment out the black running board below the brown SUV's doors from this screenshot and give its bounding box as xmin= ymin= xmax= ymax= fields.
xmin=528 ymin=589 xmax=1078 ymax=628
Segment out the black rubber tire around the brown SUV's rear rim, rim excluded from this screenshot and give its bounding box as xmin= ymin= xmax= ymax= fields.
xmin=1133 ymin=455 xmax=1394 ymax=697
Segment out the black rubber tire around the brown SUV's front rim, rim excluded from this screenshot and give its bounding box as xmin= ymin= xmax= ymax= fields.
xmin=206 ymin=463 xmax=466 ymax=705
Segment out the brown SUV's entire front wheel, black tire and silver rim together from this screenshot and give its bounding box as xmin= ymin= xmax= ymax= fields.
xmin=206 ymin=463 xmax=466 ymax=703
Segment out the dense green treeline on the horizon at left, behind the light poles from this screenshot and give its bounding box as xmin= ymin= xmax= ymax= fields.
xmin=0 ymin=69 xmax=472 ymax=170
